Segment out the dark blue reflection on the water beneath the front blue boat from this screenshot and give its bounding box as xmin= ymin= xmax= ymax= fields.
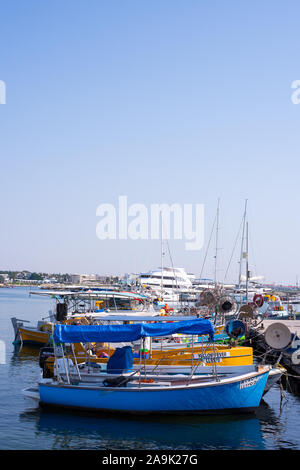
xmin=20 ymin=408 xmax=264 ymax=450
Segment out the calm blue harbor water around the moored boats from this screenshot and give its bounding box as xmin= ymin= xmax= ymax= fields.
xmin=0 ymin=287 xmax=300 ymax=450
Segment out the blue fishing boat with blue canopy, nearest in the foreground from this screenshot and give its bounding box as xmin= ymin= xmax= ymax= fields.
xmin=27 ymin=319 xmax=270 ymax=414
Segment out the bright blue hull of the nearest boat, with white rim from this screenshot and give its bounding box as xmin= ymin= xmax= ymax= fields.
xmin=39 ymin=370 xmax=269 ymax=414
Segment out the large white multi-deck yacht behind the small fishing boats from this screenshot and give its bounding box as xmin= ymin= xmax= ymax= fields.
xmin=139 ymin=267 xmax=193 ymax=302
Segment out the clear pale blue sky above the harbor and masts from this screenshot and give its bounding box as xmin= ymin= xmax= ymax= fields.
xmin=0 ymin=0 xmax=300 ymax=284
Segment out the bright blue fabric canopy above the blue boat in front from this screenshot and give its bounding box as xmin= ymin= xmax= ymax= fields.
xmin=54 ymin=319 xmax=214 ymax=343
